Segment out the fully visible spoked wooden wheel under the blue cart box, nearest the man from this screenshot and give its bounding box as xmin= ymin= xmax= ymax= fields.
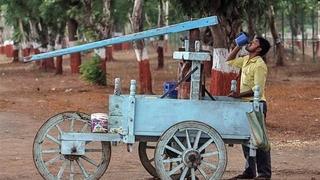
xmin=155 ymin=121 xmax=227 ymax=180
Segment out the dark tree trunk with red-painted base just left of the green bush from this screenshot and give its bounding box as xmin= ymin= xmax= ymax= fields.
xmin=68 ymin=19 xmax=81 ymax=74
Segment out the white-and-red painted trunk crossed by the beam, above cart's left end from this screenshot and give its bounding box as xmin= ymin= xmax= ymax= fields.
xmin=130 ymin=0 xmax=152 ymax=94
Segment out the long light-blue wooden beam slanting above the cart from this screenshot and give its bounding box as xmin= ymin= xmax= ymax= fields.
xmin=25 ymin=16 xmax=218 ymax=61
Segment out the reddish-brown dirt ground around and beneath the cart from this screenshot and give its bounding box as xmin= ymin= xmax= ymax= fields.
xmin=0 ymin=48 xmax=320 ymax=180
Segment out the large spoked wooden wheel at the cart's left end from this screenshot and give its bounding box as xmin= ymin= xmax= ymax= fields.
xmin=33 ymin=112 xmax=111 ymax=180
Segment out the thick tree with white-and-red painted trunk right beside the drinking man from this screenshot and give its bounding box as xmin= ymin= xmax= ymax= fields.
xmin=173 ymin=0 xmax=242 ymax=95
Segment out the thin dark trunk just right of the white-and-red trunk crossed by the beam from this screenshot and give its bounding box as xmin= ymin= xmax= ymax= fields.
xmin=157 ymin=0 xmax=164 ymax=69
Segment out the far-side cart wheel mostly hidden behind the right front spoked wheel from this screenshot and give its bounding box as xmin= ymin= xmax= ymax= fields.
xmin=139 ymin=141 xmax=158 ymax=178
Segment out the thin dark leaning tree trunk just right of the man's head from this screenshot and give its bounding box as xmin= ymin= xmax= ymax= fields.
xmin=267 ymin=0 xmax=284 ymax=66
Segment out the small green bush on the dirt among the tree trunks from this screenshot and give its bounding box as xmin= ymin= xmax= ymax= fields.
xmin=80 ymin=55 xmax=107 ymax=85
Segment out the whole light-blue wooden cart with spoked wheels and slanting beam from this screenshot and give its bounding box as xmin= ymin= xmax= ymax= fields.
xmin=31 ymin=17 xmax=259 ymax=180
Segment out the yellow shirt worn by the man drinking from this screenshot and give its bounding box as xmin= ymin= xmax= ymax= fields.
xmin=227 ymin=55 xmax=268 ymax=101
